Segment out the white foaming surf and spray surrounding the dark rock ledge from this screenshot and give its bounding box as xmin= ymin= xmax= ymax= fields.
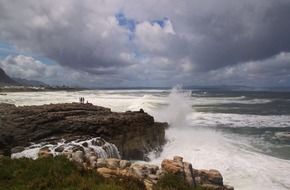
xmin=0 ymin=89 xmax=290 ymax=190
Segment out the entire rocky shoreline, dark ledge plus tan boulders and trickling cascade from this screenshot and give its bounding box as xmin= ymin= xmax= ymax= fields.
xmin=0 ymin=103 xmax=234 ymax=190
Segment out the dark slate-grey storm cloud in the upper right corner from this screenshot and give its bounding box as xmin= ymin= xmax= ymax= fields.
xmin=187 ymin=0 xmax=290 ymax=70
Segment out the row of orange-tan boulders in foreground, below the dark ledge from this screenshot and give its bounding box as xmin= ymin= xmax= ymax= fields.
xmin=55 ymin=153 xmax=234 ymax=190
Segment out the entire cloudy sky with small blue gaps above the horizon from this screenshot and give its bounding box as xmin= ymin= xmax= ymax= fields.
xmin=0 ymin=0 xmax=290 ymax=87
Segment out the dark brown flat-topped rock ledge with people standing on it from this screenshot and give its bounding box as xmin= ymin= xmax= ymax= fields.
xmin=0 ymin=103 xmax=167 ymax=160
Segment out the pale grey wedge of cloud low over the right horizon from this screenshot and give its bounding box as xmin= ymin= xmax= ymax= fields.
xmin=209 ymin=52 xmax=290 ymax=86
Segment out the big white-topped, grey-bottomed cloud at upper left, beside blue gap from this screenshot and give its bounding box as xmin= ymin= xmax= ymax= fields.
xmin=0 ymin=1 xmax=128 ymax=74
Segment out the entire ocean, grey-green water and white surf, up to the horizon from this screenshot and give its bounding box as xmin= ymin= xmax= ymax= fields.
xmin=0 ymin=88 xmax=290 ymax=190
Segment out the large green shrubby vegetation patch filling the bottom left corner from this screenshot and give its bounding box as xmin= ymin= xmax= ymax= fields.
xmin=0 ymin=157 xmax=145 ymax=190
